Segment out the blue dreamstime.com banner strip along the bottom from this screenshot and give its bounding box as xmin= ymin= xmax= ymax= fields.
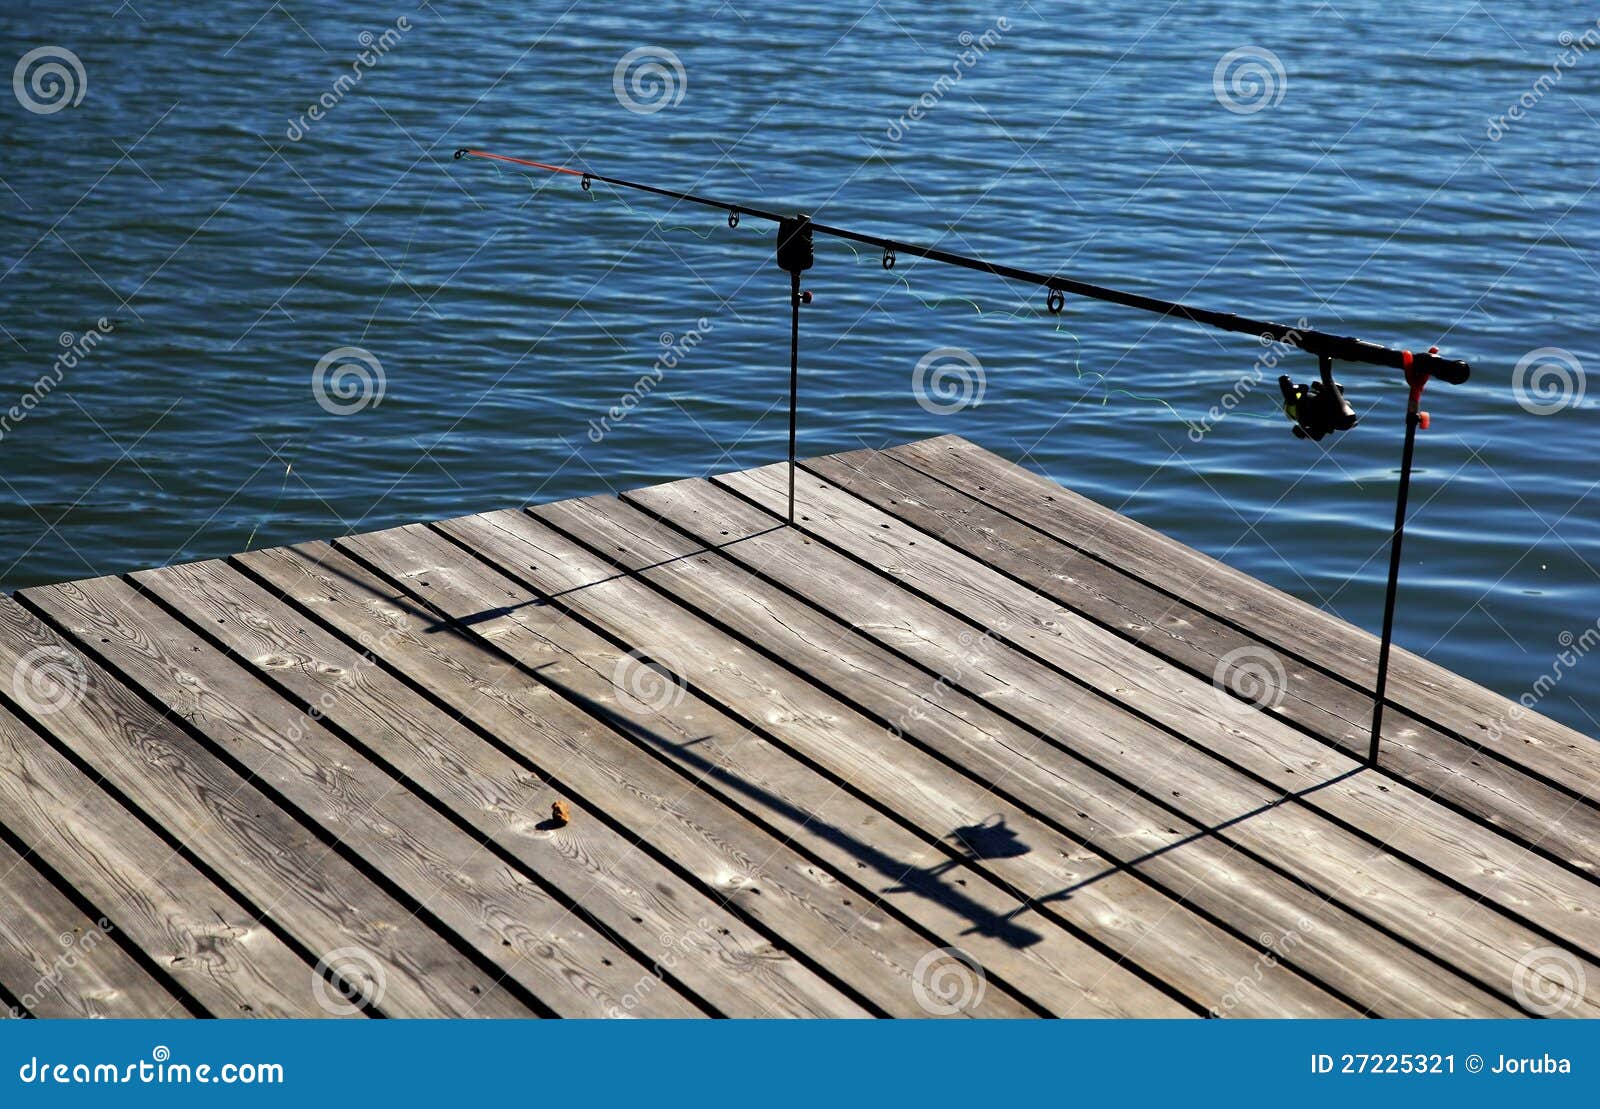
xmin=0 ymin=1021 xmax=1600 ymax=1109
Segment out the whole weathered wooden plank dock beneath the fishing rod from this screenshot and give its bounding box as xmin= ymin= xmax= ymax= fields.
xmin=0 ymin=437 xmax=1600 ymax=1016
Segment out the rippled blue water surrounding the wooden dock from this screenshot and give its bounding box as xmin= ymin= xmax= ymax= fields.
xmin=0 ymin=0 xmax=1600 ymax=733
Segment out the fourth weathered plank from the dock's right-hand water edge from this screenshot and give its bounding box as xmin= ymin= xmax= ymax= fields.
xmin=626 ymin=480 xmax=1600 ymax=1015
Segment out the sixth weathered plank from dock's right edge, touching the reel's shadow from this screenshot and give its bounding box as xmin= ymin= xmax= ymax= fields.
xmin=440 ymin=514 xmax=1352 ymax=1015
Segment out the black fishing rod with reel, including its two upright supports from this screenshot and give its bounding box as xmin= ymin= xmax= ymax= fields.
xmin=454 ymin=147 xmax=1472 ymax=767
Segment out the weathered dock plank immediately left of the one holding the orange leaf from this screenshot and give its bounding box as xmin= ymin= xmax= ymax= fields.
xmin=29 ymin=578 xmax=698 ymax=1016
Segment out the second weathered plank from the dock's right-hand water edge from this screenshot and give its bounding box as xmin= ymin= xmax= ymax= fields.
xmin=806 ymin=451 xmax=1600 ymax=871
